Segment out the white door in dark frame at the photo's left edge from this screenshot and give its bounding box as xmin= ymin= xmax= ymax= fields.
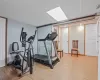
xmin=0 ymin=18 xmax=6 ymax=67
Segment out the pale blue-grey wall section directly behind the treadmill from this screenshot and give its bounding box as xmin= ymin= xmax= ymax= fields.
xmin=37 ymin=26 xmax=52 ymax=55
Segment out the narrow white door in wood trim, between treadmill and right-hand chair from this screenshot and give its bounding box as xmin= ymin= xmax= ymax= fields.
xmin=62 ymin=28 xmax=68 ymax=53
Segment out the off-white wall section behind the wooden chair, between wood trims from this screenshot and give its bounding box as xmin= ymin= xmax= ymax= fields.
xmin=69 ymin=26 xmax=84 ymax=54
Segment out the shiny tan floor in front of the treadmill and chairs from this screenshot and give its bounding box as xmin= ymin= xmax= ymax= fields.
xmin=19 ymin=55 xmax=98 ymax=80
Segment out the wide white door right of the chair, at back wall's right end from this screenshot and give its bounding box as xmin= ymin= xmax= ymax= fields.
xmin=85 ymin=24 xmax=98 ymax=56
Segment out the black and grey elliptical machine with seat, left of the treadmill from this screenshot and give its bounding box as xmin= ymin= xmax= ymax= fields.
xmin=11 ymin=28 xmax=36 ymax=74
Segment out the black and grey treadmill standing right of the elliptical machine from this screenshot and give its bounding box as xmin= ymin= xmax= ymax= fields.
xmin=34 ymin=32 xmax=59 ymax=69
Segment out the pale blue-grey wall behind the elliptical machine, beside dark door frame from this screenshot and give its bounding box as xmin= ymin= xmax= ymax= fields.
xmin=7 ymin=19 xmax=37 ymax=62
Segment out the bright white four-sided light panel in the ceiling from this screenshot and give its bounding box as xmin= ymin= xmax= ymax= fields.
xmin=47 ymin=7 xmax=68 ymax=21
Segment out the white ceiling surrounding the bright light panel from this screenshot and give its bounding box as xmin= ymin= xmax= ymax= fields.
xmin=0 ymin=0 xmax=100 ymax=26
